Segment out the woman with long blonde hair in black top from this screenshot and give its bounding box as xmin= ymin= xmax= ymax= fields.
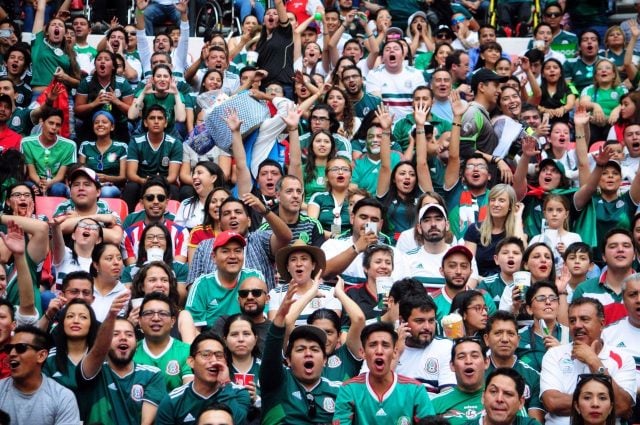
xmin=464 ymin=184 xmax=527 ymax=276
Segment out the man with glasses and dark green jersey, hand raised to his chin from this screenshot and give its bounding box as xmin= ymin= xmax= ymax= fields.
xmin=155 ymin=333 xmax=250 ymax=425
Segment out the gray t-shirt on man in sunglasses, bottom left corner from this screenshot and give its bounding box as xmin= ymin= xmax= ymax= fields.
xmin=0 ymin=375 xmax=80 ymax=425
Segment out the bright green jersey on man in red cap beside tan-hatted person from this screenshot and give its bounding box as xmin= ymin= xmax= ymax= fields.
xmin=186 ymin=269 xmax=264 ymax=327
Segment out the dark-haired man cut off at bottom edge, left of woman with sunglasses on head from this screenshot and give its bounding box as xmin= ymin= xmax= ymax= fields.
xmin=468 ymin=367 xmax=540 ymax=425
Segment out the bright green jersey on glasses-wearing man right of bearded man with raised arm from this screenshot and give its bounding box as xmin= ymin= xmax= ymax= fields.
xmin=133 ymin=337 xmax=193 ymax=392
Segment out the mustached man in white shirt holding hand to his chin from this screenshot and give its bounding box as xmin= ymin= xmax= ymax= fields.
xmin=540 ymin=297 xmax=637 ymax=425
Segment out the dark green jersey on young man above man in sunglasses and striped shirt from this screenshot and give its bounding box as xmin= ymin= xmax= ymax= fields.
xmin=127 ymin=133 xmax=182 ymax=178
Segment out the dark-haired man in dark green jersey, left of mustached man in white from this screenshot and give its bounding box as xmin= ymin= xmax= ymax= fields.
xmin=484 ymin=310 xmax=545 ymax=423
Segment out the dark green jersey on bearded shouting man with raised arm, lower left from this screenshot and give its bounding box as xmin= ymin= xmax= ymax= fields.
xmin=76 ymin=362 xmax=167 ymax=425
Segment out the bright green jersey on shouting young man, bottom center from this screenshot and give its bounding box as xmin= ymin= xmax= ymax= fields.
xmin=333 ymin=372 xmax=434 ymax=425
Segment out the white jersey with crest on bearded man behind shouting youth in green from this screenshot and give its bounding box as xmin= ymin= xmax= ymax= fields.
xmin=396 ymin=338 xmax=456 ymax=394
